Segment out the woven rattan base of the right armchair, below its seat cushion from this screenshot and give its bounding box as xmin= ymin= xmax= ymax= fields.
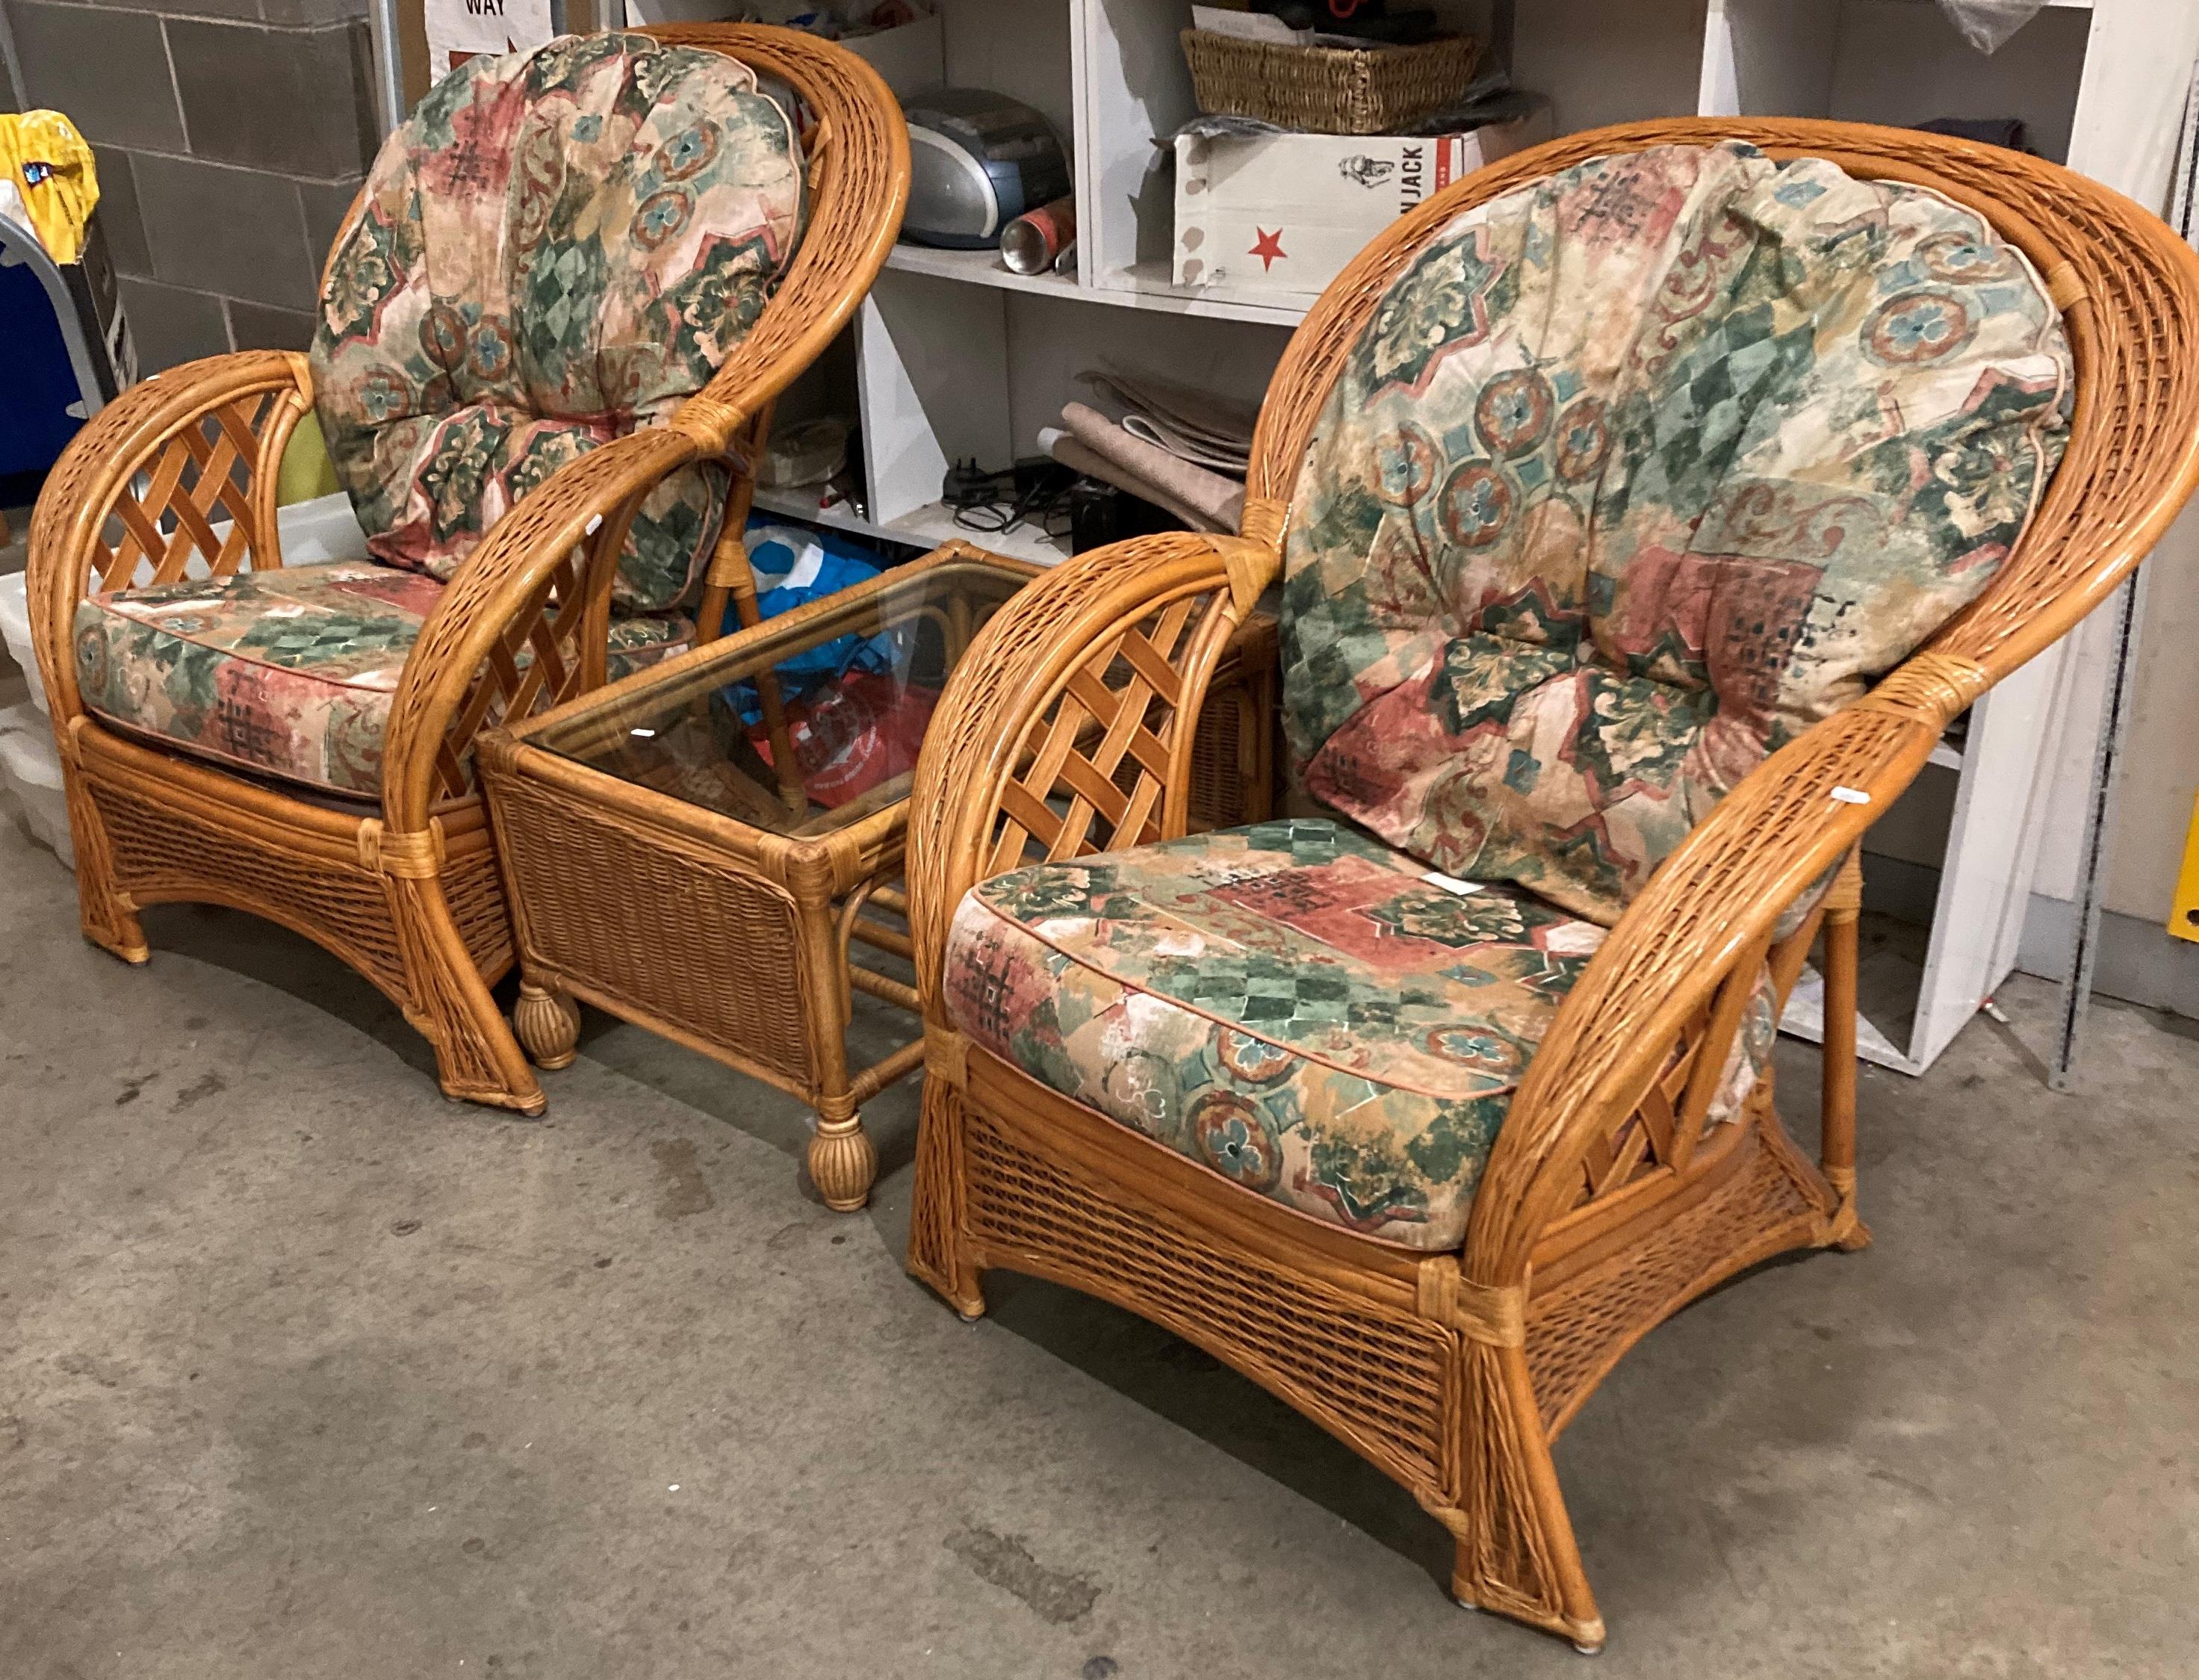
xmin=911 ymin=1047 xmax=1867 ymax=1649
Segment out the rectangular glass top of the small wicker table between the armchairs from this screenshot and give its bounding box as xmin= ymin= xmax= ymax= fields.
xmin=528 ymin=557 xmax=1032 ymax=838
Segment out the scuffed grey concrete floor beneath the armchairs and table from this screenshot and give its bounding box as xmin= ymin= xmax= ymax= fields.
xmin=0 ymin=829 xmax=2199 ymax=1680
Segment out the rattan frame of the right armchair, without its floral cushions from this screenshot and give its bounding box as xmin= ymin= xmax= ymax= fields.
xmin=908 ymin=121 xmax=2199 ymax=1649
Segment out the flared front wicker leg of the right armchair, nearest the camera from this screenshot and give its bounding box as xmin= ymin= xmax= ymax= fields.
xmin=1451 ymin=1342 xmax=1603 ymax=1652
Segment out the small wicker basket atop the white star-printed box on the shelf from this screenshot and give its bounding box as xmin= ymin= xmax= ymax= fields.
xmin=1183 ymin=28 xmax=1482 ymax=134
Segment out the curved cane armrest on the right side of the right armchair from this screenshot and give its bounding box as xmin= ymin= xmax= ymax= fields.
xmin=1465 ymin=690 xmax=1983 ymax=1286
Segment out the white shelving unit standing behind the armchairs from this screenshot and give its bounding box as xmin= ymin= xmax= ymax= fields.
xmin=725 ymin=0 xmax=2199 ymax=1073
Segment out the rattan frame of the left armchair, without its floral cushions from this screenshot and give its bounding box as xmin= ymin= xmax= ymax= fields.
xmin=28 ymin=24 xmax=908 ymax=1113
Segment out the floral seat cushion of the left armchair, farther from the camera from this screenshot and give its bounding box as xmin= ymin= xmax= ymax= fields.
xmin=75 ymin=565 xmax=695 ymax=799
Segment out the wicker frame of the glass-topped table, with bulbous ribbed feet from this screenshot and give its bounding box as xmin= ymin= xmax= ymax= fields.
xmin=480 ymin=543 xmax=1276 ymax=1212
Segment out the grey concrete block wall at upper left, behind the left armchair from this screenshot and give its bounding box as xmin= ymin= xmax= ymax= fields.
xmin=0 ymin=0 xmax=373 ymax=371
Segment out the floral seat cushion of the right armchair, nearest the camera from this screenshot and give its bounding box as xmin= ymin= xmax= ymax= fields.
xmin=946 ymin=820 xmax=1775 ymax=1249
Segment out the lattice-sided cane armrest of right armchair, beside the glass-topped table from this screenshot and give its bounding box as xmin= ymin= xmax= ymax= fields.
xmin=908 ymin=532 xmax=1282 ymax=1009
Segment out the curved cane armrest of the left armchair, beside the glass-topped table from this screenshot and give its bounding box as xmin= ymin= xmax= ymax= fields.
xmin=382 ymin=427 xmax=706 ymax=831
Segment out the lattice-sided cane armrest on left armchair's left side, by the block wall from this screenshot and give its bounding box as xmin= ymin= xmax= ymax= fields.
xmin=26 ymin=350 xmax=312 ymax=723
